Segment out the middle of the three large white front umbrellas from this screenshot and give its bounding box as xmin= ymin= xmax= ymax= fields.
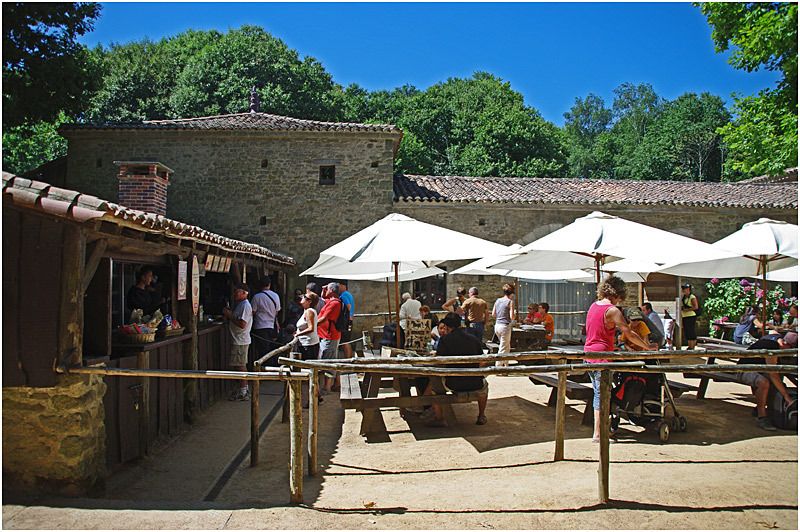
xmin=490 ymin=211 xmax=733 ymax=283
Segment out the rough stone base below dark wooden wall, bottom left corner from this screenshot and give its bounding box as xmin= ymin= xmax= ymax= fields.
xmin=3 ymin=375 xmax=106 ymax=496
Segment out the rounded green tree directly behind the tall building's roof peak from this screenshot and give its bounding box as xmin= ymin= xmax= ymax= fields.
xmin=170 ymin=26 xmax=341 ymax=120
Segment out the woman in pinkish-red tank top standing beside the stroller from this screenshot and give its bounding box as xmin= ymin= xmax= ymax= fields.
xmin=583 ymin=275 xmax=653 ymax=443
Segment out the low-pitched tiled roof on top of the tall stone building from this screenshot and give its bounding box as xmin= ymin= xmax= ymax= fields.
xmin=61 ymin=113 xmax=401 ymax=133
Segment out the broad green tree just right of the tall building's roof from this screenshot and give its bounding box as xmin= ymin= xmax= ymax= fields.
xmin=384 ymin=72 xmax=566 ymax=177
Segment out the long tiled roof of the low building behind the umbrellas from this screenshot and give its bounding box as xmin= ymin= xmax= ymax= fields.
xmin=394 ymin=175 xmax=797 ymax=209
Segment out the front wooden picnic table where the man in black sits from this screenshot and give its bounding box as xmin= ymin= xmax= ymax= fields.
xmin=339 ymin=348 xmax=486 ymax=437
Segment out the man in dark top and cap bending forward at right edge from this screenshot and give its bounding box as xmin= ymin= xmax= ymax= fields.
xmin=734 ymin=332 xmax=797 ymax=430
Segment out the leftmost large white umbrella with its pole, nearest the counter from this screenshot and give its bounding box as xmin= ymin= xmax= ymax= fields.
xmin=300 ymin=213 xmax=506 ymax=348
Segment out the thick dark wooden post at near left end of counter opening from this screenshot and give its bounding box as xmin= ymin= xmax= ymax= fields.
xmin=58 ymin=224 xmax=86 ymax=366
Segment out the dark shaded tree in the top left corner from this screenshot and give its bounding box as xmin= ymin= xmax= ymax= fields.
xmin=3 ymin=2 xmax=100 ymax=127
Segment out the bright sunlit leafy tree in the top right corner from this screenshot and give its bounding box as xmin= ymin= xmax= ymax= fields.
xmin=699 ymin=2 xmax=798 ymax=175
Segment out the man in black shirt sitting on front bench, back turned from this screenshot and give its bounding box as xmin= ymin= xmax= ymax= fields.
xmin=425 ymin=312 xmax=488 ymax=427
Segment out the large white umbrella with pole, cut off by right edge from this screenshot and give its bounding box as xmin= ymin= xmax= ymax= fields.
xmin=660 ymin=218 xmax=798 ymax=325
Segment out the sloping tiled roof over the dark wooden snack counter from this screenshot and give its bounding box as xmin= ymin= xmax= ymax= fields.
xmin=3 ymin=172 xmax=295 ymax=266
